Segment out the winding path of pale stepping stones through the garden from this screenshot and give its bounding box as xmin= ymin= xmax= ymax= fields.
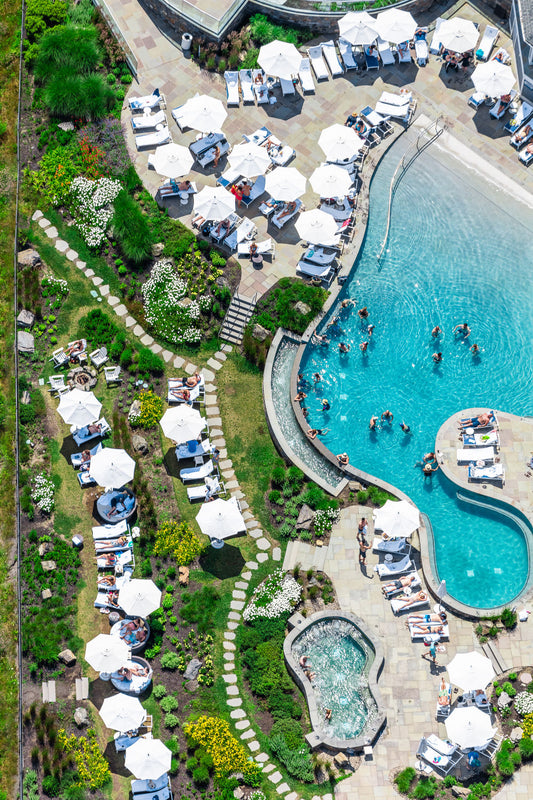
xmin=32 ymin=210 xmax=299 ymax=800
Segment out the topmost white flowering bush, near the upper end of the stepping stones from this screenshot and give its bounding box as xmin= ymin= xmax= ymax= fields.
xmin=70 ymin=176 xmax=122 ymax=247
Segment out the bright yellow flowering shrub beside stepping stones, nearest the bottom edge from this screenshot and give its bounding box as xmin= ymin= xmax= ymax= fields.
xmin=183 ymin=717 xmax=259 ymax=780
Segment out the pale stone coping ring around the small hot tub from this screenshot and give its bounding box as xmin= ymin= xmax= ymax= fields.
xmin=283 ymin=609 xmax=387 ymax=751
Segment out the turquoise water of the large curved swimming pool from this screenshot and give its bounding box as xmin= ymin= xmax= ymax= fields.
xmin=302 ymin=137 xmax=533 ymax=608
